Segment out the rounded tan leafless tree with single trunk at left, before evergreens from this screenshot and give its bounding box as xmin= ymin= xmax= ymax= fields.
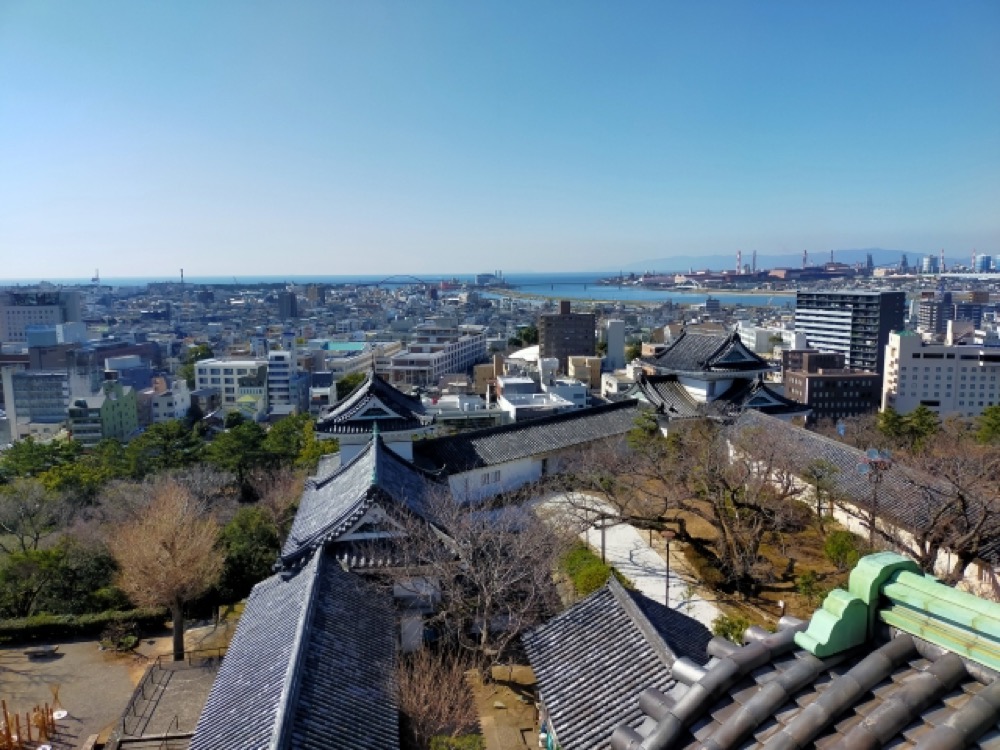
xmin=108 ymin=480 xmax=222 ymax=661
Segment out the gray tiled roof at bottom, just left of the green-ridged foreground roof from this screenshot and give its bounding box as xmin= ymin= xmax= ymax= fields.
xmin=523 ymin=579 xmax=711 ymax=750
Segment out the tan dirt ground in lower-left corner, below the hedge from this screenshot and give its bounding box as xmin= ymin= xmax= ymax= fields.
xmin=0 ymin=621 xmax=235 ymax=750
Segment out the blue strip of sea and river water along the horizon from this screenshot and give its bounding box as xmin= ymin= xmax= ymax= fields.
xmin=0 ymin=272 xmax=795 ymax=307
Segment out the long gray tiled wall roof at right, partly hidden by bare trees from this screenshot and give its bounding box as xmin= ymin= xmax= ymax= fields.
xmin=735 ymin=411 xmax=1000 ymax=560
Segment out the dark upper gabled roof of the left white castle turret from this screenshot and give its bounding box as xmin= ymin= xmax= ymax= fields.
xmin=316 ymin=373 xmax=432 ymax=434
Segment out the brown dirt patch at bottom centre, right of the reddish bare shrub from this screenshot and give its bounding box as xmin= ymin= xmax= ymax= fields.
xmin=470 ymin=666 xmax=538 ymax=750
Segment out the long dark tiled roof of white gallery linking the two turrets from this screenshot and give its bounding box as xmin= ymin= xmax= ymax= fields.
xmin=413 ymin=400 xmax=642 ymax=474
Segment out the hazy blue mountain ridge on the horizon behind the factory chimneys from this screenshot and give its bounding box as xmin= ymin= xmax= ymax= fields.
xmin=621 ymin=247 xmax=932 ymax=273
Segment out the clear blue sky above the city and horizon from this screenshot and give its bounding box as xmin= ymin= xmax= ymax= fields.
xmin=0 ymin=0 xmax=1000 ymax=278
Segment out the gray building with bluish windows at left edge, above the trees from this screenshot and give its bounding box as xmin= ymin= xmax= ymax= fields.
xmin=2 ymin=367 xmax=69 ymax=440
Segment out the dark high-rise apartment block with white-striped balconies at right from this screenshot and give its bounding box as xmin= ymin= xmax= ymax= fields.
xmin=795 ymin=291 xmax=906 ymax=373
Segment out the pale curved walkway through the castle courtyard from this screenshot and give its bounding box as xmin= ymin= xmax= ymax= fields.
xmin=536 ymin=493 xmax=722 ymax=628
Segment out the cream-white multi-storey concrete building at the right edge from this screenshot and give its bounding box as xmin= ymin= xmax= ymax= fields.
xmin=882 ymin=324 xmax=1000 ymax=417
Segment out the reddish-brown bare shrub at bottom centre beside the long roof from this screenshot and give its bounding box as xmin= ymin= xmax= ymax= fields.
xmin=396 ymin=648 xmax=479 ymax=750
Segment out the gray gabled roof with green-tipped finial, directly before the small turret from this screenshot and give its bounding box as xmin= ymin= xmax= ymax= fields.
xmin=281 ymin=436 xmax=439 ymax=565
